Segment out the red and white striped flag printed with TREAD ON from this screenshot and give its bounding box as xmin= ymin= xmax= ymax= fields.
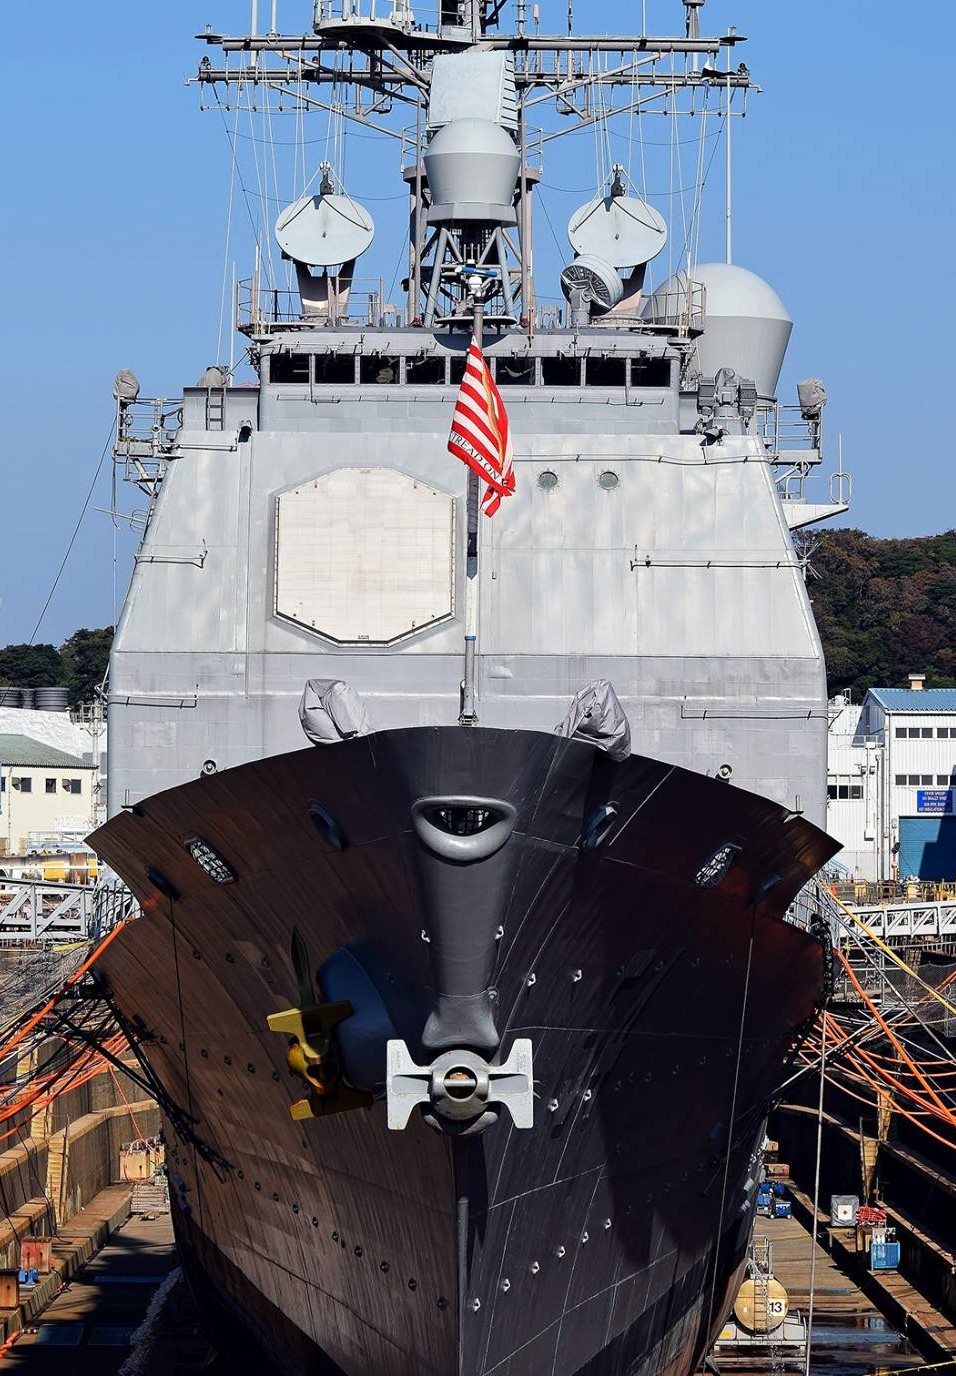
xmin=448 ymin=338 xmax=514 ymax=516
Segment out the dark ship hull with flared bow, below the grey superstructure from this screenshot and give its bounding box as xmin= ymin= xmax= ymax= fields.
xmin=94 ymin=728 xmax=834 ymax=1376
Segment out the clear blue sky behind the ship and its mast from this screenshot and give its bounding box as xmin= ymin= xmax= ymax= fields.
xmin=0 ymin=0 xmax=956 ymax=645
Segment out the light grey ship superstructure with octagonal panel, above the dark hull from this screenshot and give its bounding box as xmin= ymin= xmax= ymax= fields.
xmin=101 ymin=7 xmax=840 ymax=820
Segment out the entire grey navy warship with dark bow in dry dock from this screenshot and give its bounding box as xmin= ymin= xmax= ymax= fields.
xmin=92 ymin=0 xmax=845 ymax=1376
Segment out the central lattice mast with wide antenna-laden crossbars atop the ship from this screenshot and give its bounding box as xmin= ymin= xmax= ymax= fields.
xmin=195 ymin=0 xmax=759 ymax=333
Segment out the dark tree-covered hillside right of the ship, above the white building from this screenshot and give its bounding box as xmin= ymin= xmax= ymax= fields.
xmin=809 ymin=530 xmax=956 ymax=702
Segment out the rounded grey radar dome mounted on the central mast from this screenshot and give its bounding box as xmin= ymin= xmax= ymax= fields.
xmin=425 ymin=120 xmax=521 ymax=224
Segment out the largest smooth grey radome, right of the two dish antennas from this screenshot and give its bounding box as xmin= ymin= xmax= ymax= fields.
xmin=641 ymin=263 xmax=794 ymax=398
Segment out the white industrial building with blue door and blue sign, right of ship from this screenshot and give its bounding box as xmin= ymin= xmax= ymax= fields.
xmin=827 ymin=674 xmax=956 ymax=882
